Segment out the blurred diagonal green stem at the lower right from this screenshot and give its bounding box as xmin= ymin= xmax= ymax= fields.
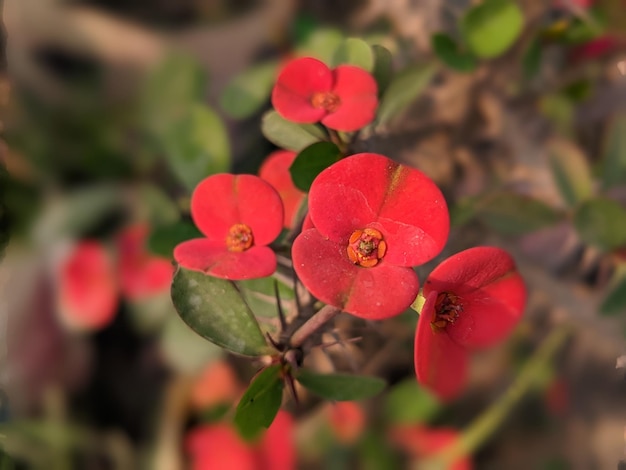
xmin=420 ymin=326 xmax=570 ymax=470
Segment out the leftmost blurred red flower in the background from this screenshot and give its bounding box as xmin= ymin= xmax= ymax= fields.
xmin=57 ymin=240 xmax=118 ymax=330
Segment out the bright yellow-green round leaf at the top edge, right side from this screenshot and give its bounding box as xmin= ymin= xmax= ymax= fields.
xmin=461 ymin=0 xmax=524 ymax=59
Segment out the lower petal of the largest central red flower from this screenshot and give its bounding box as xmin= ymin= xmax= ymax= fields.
xmin=292 ymin=229 xmax=419 ymax=320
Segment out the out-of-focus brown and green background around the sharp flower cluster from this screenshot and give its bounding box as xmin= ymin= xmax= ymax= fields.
xmin=0 ymin=0 xmax=626 ymax=470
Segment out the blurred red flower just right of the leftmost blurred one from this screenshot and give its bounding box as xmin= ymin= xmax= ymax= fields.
xmin=117 ymin=224 xmax=174 ymax=300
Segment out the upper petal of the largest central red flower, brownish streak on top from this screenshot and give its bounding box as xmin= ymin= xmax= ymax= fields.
xmin=309 ymin=153 xmax=449 ymax=266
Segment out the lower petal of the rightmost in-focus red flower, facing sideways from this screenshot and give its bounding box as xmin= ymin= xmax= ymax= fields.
xmin=414 ymin=292 xmax=468 ymax=401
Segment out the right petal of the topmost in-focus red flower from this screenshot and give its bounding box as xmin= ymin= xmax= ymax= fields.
xmin=322 ymin=65 xmax=378 ymax=132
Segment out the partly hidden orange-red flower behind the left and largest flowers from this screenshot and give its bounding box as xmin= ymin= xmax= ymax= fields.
xmin=259 ymin=150 xmax=305 ymax=228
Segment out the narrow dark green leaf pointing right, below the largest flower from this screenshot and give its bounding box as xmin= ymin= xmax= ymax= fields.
xmin=296 ymin=369 xmax=387 ymax=401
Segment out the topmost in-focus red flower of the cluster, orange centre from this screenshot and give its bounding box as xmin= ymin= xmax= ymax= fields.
xmin=272 ymin=57 xmax=378 ymax=132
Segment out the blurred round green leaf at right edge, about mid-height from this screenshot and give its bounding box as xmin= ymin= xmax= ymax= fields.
xmin=574 ymin=198 xmax=626 ymax=251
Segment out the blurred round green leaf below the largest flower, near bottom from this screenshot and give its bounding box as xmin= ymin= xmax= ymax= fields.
xmin=385 ymin=379 xmax=441 ymax=424
